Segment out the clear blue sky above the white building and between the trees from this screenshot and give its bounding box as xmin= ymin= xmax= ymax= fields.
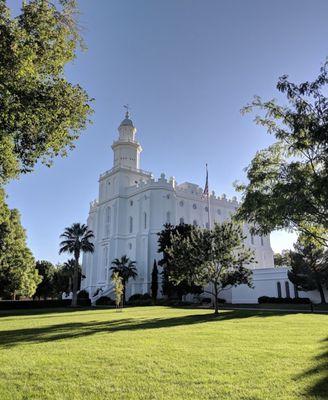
xmin=7 ymin=0 xmax=328 ymax=262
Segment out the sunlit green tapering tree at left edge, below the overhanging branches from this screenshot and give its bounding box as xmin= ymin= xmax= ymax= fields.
xmin=0 ymin=189 xmax=42 ymax=299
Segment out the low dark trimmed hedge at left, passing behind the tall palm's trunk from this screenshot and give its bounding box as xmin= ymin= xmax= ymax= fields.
xmin=0 ymin=299 xmax=91 ymax=310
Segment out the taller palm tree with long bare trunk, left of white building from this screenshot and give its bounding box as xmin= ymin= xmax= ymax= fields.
xmin=59 ymin=223 xmax=94 ymax=307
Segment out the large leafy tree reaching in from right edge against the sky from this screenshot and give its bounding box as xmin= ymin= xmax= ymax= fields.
xmin=237 ymin=61 xmax=328 ymax=245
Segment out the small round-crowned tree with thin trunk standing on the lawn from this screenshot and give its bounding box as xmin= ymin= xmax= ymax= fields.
xmin=166 ymin=222 xmax=254 ymax=314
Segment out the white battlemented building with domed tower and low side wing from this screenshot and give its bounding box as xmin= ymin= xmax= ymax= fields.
xmin=82 ymin=112 xmax=322 ymax=303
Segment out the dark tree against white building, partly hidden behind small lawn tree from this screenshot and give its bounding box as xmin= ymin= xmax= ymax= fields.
xmin=158 ymin=224 xmax=203 ymax=300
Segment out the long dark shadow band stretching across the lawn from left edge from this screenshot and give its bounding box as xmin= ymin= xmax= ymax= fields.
xmin=0 ymin=310 xmax=290 ymax=349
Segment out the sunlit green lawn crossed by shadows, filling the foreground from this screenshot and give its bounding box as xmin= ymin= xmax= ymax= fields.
xmin=0 ymin=307 xmax=328 ymax=400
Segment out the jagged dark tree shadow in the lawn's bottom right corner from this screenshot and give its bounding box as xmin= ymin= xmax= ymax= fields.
xmin=297 ymin=337 xmax=328 ymax=399
